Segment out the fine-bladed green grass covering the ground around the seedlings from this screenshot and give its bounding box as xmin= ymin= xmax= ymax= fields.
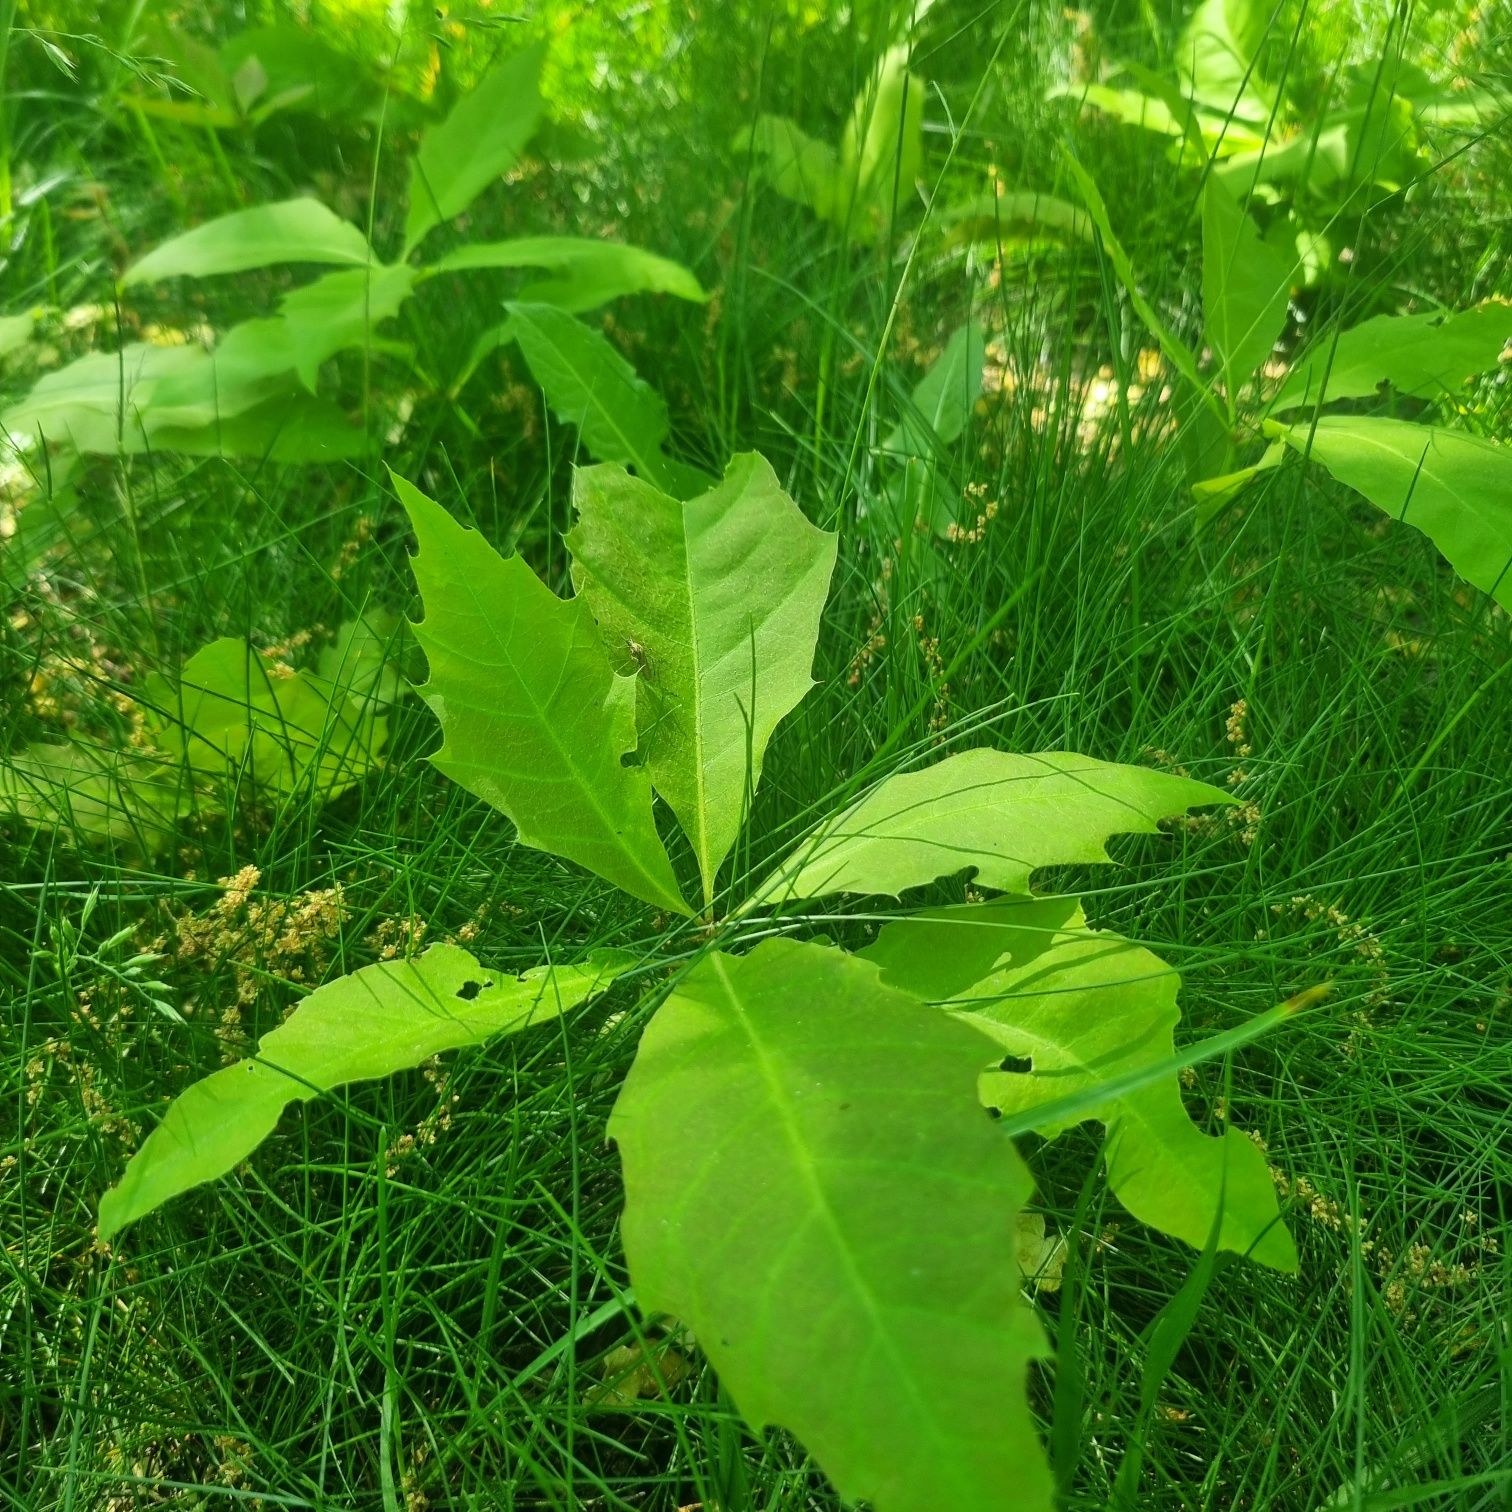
xmin=0 ymin=0 xmax=1512 ymax=1512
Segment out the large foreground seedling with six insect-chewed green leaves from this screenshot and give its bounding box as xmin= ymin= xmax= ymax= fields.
xmin=100 ymin=455 xmax=1296 ymax=1512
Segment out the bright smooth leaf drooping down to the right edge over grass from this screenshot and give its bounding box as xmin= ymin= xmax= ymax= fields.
xmin=1278 ymin=414 xmax=1512 ymax=609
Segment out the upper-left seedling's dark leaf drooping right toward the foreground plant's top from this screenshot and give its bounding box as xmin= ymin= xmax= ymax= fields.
xmin=505 ymin=304 xmax=702 ymax=496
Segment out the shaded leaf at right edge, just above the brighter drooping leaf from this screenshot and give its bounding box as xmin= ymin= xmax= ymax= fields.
xmin=1270 ymin=299 xmax=1512 ymax=411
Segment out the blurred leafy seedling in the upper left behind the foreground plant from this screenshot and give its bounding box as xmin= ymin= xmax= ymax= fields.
xmin=0 ymin=47 xmax=703 ymax=479
